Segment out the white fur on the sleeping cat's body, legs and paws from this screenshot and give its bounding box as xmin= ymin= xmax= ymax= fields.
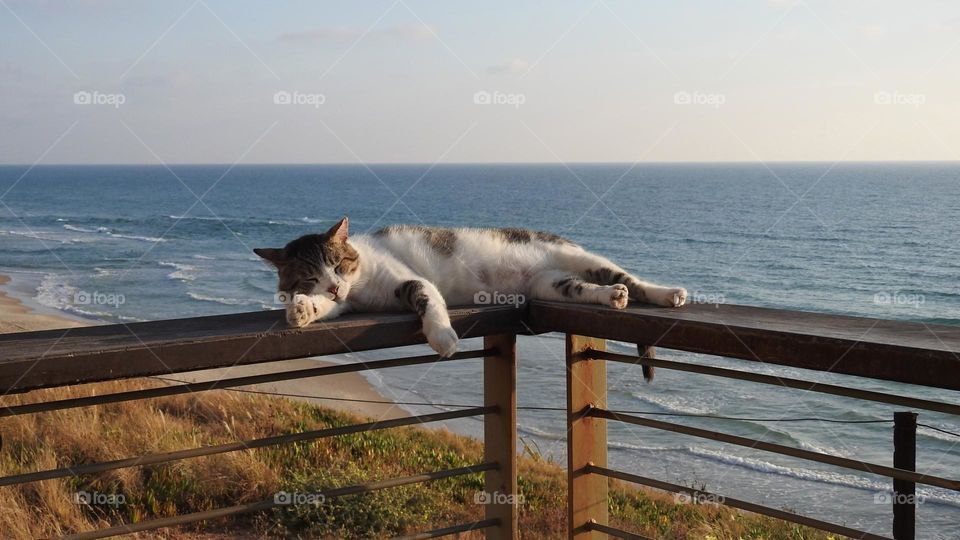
xmin=287 ymin=228 xmax=687 ymax=356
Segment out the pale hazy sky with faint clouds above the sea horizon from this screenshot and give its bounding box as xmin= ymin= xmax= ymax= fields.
xmin=0 ymin=0 xmax=960 ymax=164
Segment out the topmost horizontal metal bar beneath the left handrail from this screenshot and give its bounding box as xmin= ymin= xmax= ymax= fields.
xmin=0 ymin=349 xmax=496 ymax=418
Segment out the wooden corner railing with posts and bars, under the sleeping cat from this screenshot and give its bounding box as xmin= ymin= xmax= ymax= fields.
xmin=0 ymin=301 xmax=960 ymax=540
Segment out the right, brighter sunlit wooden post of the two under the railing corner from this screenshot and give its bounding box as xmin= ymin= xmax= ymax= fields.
xmin=567 ymin=334 xmax=608 ymax=540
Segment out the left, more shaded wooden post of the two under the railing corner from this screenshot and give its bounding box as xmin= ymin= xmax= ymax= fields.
xmin=483 ymin=334 xmax=521 ymax=540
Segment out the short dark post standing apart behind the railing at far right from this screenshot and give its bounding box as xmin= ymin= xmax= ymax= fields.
xmin=893 ymin=412 xmax=917 ymax=540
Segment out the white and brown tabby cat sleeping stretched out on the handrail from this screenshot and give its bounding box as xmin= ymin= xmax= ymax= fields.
xmin=253 ymin=217 xmax=687 ymax=379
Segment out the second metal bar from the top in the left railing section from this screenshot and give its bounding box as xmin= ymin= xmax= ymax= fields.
xmin=0 ymin=407 xmax=499 ymax=486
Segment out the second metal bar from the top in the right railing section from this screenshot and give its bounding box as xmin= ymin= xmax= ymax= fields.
xmin=592 ymin=408 xmax=960 ymax=491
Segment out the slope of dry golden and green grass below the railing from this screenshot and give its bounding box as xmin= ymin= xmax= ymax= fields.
xmin=0 ymin=381 xmax=829 ymax=540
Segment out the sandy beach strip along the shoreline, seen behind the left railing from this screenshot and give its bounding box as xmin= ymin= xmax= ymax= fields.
xmin=0 ymin=275 xmax=408 ymax=420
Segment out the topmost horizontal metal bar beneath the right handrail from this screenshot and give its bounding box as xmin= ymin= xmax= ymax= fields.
xmin=596 ymin=350 xmax=960 ymax=415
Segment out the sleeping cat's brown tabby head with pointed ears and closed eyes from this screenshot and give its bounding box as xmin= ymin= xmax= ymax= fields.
xmin=253 ymin=218 xmax=360 ymax=302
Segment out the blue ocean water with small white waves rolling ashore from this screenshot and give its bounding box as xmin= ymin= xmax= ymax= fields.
xmin=0 ymin=163 xmax=960 ymax=538
